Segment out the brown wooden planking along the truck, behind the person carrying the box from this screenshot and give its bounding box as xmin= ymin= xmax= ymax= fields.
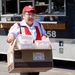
xmin=0 ymin=23 xmax=66 ymax=30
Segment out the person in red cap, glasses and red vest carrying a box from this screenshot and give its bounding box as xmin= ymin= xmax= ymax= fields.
xmin=6 ymin=5 xmax=47 ymax=75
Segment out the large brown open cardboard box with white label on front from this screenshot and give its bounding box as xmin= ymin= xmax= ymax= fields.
xmin=7 ymin=42 xmax=53 ymax=73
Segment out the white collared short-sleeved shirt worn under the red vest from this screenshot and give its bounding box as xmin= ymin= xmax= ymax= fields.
xmin=8 ymin=20 xmax=47 ymax=40
